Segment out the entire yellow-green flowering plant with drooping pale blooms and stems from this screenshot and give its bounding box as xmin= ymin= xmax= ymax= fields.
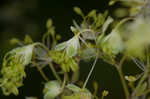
xmin=0 ymin=0 xmax=150 ymax=99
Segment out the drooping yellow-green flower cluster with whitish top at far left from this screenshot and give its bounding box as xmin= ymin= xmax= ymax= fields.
xmin=0 ymin=44 xmax=34 ymax=95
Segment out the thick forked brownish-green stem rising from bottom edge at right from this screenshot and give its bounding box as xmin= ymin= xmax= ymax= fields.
xmin=115 ymin=56 xmax=130 ymax=99
